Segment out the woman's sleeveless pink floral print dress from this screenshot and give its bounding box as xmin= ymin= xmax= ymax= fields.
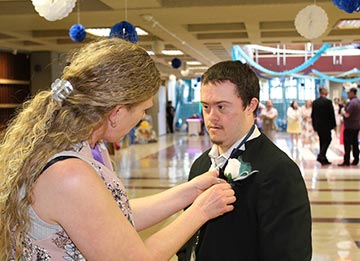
xmin=22 ymin=142 xmax=134 ymax=261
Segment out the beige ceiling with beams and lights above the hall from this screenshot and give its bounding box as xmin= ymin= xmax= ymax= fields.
xmin=0 ymin=0 xmax=360 ymax=76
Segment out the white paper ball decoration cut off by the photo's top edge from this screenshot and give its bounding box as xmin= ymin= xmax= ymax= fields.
xmin=32 ymin=0 xmax=76 ymax=21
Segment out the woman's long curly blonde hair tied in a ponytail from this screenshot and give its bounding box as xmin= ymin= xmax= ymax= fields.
xmin=0 ymin=38 xmax=160 ymax=260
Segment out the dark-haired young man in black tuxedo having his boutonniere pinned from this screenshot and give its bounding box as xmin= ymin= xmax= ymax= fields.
xmin=178 ymin=61 xmax=312 ymax=261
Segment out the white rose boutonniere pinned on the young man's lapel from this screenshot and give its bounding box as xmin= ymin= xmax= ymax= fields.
xmin=224 ymin=157 xmax=259 ymax=183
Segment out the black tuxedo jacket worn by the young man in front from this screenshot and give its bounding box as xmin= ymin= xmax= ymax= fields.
xmin=178 ymin=134 xmax=312 ymax=261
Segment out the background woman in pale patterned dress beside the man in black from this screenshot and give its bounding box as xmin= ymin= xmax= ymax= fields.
xmin=301 ymin=100 xmax=315 ymax=148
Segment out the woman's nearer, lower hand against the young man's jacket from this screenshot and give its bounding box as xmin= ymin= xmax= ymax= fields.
xmin=192 ymin=182 xmax=236 ymax=220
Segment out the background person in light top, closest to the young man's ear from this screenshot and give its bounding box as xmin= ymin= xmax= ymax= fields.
xmin=260 ymin=100 xmax=278 ymax=142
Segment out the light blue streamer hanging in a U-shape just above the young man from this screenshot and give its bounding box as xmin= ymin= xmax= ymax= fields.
xmin=232 ymin=43 xmax=331 ymax=76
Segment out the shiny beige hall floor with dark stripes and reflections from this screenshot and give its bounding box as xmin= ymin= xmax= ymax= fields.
xmin=114 ymin=133 xmax=360 ymax=261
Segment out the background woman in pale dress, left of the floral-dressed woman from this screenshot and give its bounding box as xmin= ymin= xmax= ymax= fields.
xmin=286 ymin=101 xmax=301 ymax=148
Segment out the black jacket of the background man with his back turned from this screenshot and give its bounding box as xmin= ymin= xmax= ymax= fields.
xmin=311 ymin=97 xmax=336 ymax=132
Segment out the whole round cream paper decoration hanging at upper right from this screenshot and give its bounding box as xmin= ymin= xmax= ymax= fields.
xmin=295 ymin=5 xmax=328 ymax=39
